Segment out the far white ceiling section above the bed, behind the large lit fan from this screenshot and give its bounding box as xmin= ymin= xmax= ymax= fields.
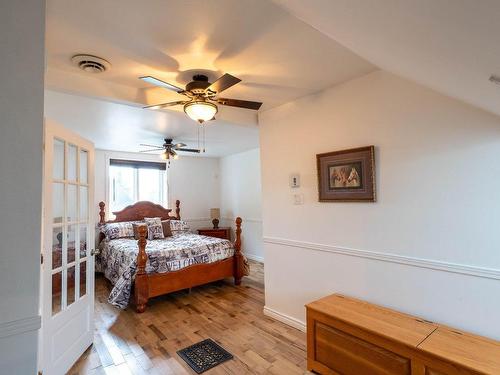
xmin=45 ymin=90 xmax=259 ymax=157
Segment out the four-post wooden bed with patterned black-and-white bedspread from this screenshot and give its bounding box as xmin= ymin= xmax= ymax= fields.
xmin=97 ymin=201 xmax=247 ymax=313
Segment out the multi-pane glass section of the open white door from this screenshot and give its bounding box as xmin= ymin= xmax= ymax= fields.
xmin=51 ymin=138 xmax=92 ymax=315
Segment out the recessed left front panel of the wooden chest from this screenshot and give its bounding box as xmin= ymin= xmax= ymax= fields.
xmin=314 ymin=321 xmax=411 ymax=375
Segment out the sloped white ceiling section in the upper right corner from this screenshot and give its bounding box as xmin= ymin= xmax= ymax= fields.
xmin=274 ymin=0 xmax=500 ymax=115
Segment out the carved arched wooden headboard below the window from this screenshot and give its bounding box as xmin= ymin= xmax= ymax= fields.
xmin=99 ymin=200 xmax=181 ymax=224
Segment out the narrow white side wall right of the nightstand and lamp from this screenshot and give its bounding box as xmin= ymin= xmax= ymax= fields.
xmin=220 ymin=148 xmax=264 ymax=261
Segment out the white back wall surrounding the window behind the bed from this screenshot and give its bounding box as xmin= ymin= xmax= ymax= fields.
xmin=94 ymin=150 xmax=220 ymax=230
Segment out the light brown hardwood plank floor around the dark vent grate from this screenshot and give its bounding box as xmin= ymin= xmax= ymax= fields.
xmin=69 ymin=261 xmax=306 ymax=375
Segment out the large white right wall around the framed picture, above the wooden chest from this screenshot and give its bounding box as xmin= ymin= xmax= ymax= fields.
xmin=260 ymin=71 xmax=500 ymax=339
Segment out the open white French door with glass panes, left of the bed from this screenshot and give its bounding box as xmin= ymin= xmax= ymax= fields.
xmin=39 ymin=120 xmax=95 ymax=375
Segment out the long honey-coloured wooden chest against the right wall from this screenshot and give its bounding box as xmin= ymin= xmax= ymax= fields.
xmin=306 ymin=294 xmax=500 ymax=375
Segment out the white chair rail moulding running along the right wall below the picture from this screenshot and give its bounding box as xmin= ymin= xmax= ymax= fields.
xmin=263 ymin=237 xmax=500 ymax=280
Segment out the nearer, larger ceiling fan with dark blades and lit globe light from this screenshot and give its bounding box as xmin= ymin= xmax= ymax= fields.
xmin=139 ymin=73 xmax=262 ymax=124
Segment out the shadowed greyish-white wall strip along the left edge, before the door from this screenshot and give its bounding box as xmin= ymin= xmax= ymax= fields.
xmin=0 ymin=0 xmax=45 ymax=374
